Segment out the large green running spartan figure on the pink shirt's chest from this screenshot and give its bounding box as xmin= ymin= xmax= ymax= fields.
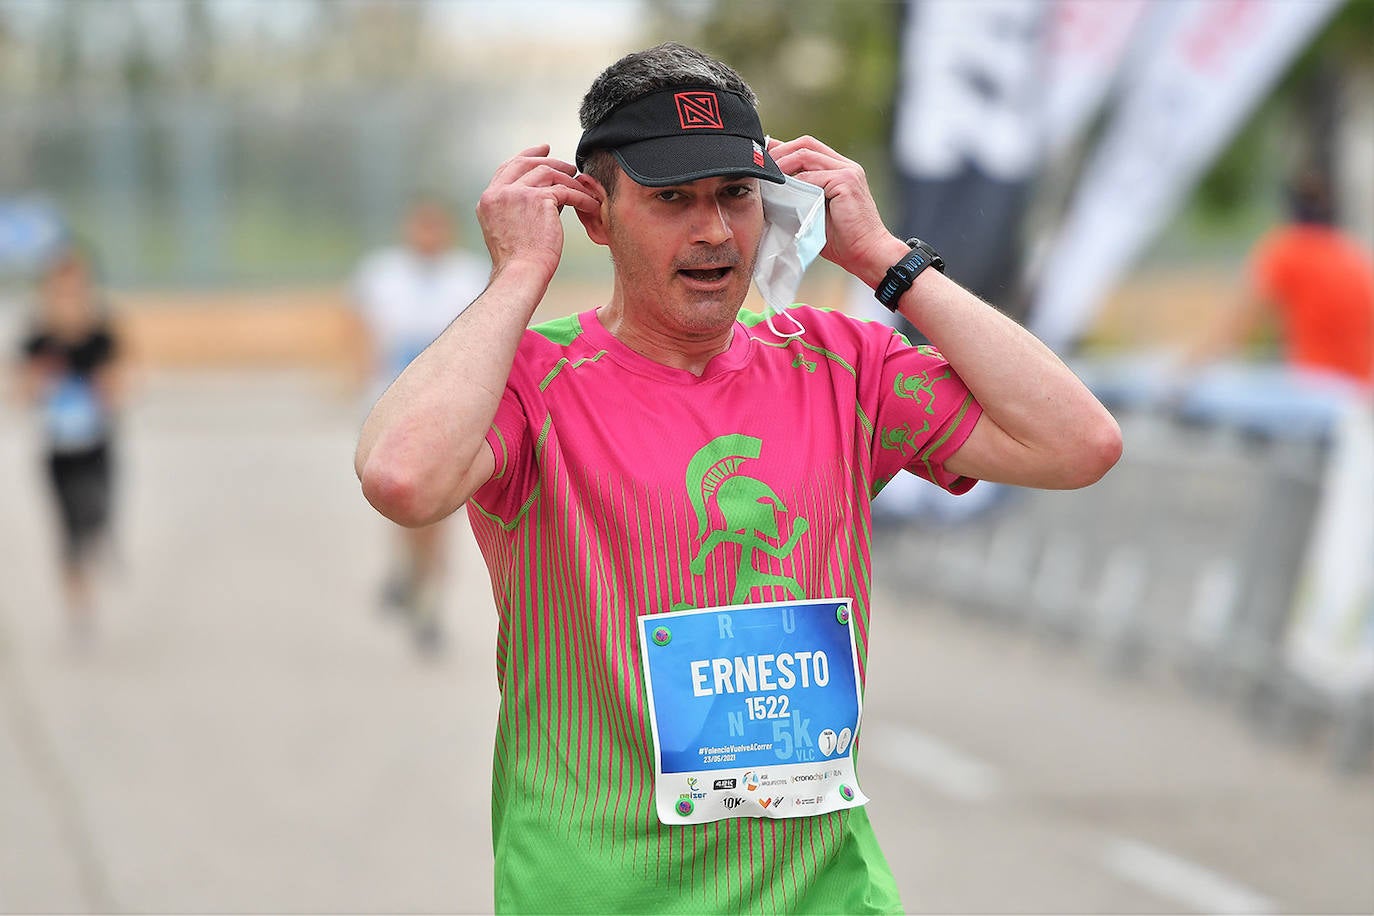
xmin=687 ymin=433 xmax=808 ymax=604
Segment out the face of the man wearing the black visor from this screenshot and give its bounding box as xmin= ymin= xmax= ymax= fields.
xmin=605 ymin=174 xmax=764 ymax=338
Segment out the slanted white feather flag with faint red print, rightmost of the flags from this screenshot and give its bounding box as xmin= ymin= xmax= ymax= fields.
xmin=1031 ymin=0 xmax=1340 ymax=352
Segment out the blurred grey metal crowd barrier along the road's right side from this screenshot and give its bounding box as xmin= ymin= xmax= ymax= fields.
xmin=879 ymin=409 xmax=1374 ymax=772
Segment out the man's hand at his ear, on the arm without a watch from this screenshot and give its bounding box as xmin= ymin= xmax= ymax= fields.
xmin=477 ymin=143 xmax=600 ymax=282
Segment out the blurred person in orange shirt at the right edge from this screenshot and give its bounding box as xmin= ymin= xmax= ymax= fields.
xmin=1180 ymin=172 xmax=1374 ymax=393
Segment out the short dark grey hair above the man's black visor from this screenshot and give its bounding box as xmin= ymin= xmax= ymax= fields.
xmin=578 ymin=41 xmax=758 ymax=130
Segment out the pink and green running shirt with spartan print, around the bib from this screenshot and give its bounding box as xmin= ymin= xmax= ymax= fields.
xmin=469 ymin=308 xmax=981 ymax=913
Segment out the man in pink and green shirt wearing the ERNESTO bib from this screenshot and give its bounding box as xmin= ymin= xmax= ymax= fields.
xmin=356 ymin=44 xmax=1121 ymax=913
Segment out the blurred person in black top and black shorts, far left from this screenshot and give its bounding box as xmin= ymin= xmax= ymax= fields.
xmin=19 ymin=247 xmax=122 ymax=636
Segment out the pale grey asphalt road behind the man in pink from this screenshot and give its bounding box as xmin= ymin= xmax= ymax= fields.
xmin=0 ymin=375 xmax=1374 ymax=913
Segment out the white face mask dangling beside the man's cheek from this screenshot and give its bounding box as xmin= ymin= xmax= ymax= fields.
xmin=754 ymin=176 xmax=826 ymax=336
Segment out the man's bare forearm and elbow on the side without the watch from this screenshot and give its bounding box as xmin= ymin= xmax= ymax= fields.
xmin=354 ymin=264 xmax=548 ymax=526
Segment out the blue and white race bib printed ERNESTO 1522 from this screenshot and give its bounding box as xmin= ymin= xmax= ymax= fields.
xmin=639 ymin=599 xmax=868 ymax=825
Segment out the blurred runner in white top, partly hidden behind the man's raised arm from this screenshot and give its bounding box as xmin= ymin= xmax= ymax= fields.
xmin=352 ymin=196 xmax=489 ymax=652
